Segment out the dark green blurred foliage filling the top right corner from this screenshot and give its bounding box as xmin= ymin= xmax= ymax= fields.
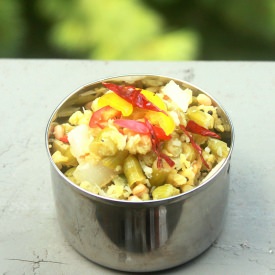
xmin=144 ymin=0 xmax=275 ymax=60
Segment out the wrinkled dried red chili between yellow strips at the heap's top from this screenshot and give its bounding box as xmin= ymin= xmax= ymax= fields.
xmin=102 ymin=82 xmax=167 ymax=115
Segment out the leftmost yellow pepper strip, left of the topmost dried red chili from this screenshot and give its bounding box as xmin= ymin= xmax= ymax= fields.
xmin=97 ymin=92 xmax=133 ymax=116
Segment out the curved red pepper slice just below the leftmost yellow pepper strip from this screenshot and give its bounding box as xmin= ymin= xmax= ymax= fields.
xmin=89 ymin=106 xmax=121 ymax=128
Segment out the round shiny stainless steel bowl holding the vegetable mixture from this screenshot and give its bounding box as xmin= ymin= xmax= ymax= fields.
xmin=46 ymin=75 xmax=234 ymax=272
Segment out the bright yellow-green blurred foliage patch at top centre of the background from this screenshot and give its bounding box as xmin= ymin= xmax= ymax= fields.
xmin=36 ymin=0 xmax=199 ymax=60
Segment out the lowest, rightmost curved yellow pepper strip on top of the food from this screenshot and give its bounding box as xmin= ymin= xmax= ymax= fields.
xmin=145 ymin=111 xmax=175 ymax=136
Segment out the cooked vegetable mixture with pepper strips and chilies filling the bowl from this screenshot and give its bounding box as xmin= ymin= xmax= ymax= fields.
xmin=50 ymin=78 xmax=229 ymax=201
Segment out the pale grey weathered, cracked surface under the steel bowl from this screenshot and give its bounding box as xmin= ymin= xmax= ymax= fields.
xmin=0 ymin=59 xmax=275 ymax=275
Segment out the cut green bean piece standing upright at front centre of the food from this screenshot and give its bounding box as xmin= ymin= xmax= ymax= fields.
xmin=123 ymin=155 xmax=146 ymax=187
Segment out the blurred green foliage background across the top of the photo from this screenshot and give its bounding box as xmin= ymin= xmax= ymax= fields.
xmin=0 ymin=0 xmax=275 ymax=60
